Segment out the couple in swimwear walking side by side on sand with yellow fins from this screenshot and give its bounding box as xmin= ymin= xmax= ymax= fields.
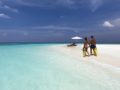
xmin=83 ymin=36 xmax=97 ymax=57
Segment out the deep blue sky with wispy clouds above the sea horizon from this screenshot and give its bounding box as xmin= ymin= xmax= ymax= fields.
xmin=0 ymin=0 xmax=120 ymax=43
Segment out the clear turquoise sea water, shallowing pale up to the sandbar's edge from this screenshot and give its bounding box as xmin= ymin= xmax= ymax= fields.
xmin=0 ymin=44 xmax=120 ymax=90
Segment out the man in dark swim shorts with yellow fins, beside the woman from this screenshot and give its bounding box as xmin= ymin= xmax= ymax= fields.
xmin=90 ymin=36 xmax=97 ymax=56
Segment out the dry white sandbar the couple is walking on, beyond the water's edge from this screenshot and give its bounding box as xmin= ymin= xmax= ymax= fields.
xmin=53 ymin=44 xmax=120 ymax=68
